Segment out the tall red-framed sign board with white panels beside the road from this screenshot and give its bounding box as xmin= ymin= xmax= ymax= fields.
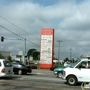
xmin=40 ymin=29 xmax=54 ymax=69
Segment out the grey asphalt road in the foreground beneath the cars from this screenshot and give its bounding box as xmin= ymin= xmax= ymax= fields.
xmin=0 ymin=69 xmax=82 ymax=90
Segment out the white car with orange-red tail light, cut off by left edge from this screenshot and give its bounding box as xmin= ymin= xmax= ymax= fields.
xmin=0 ymin=59 xmax=14 ymax=77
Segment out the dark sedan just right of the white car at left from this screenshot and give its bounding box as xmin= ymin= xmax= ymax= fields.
xmin=12 ymin=61 xmax=32 ymax=75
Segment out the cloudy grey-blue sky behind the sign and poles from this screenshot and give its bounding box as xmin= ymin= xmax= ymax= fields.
xmin=0 ymin=0 xmax=90 ymax=59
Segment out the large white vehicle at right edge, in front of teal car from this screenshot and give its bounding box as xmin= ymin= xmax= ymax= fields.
xmin=62 ymin=58 xmax=90 ymax=86
